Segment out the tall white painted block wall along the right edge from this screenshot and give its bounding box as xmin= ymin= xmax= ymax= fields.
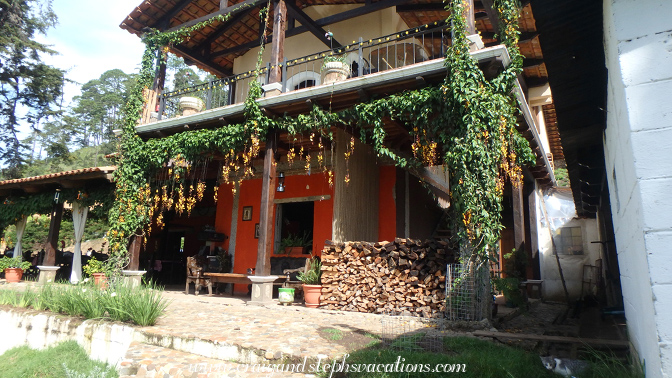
xmin=604 ymin=0 xmax=672 ymax=377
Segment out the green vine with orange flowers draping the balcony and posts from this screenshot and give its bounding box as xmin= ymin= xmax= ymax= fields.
xmin=108 ymin=0 xmax=534 ymax=269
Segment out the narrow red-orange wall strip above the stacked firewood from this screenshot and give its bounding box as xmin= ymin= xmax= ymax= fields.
xmin=378 ymin=165 xmax=397 ymax=241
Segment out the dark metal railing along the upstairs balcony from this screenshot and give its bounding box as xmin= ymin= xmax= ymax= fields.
xmin=158 ymin=22 xmax=450 ymax=119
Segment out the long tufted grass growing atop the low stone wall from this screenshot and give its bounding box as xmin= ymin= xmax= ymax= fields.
xmin=0 ymin=281 xmax=168 ymax=326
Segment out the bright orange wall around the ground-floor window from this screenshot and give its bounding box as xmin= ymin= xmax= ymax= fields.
xmin=222 ymin=174 xmax=334 ymax=293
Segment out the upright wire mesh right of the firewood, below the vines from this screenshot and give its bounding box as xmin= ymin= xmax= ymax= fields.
xmin=446 ymin=264 xmax=492 ymax=321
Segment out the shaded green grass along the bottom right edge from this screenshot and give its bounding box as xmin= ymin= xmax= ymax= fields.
xmin=334 ymin=337 xmax=643 ymax=378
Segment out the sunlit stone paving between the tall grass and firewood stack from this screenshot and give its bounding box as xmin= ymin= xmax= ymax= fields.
xmin=141 ymin=291 xmax=381 ymax=359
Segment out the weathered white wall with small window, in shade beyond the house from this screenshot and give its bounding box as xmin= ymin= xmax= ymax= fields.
xmin=535 ymin=190 xmax=602 ymax=302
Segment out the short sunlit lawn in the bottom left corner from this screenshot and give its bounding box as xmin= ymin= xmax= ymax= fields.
xmin=0 ymin=341 xmax=119 ymax=378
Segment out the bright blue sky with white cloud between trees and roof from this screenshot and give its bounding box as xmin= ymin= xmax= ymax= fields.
xmin=38 ymin=0 xmax=144 ymax=104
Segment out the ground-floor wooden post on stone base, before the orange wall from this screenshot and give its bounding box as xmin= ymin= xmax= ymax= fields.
xmin=255 ymin=131 xmax=277 ymax=276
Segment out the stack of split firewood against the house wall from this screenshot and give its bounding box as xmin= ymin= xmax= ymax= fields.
xmin=321 ymin=238 xmax=455 ymax=316
